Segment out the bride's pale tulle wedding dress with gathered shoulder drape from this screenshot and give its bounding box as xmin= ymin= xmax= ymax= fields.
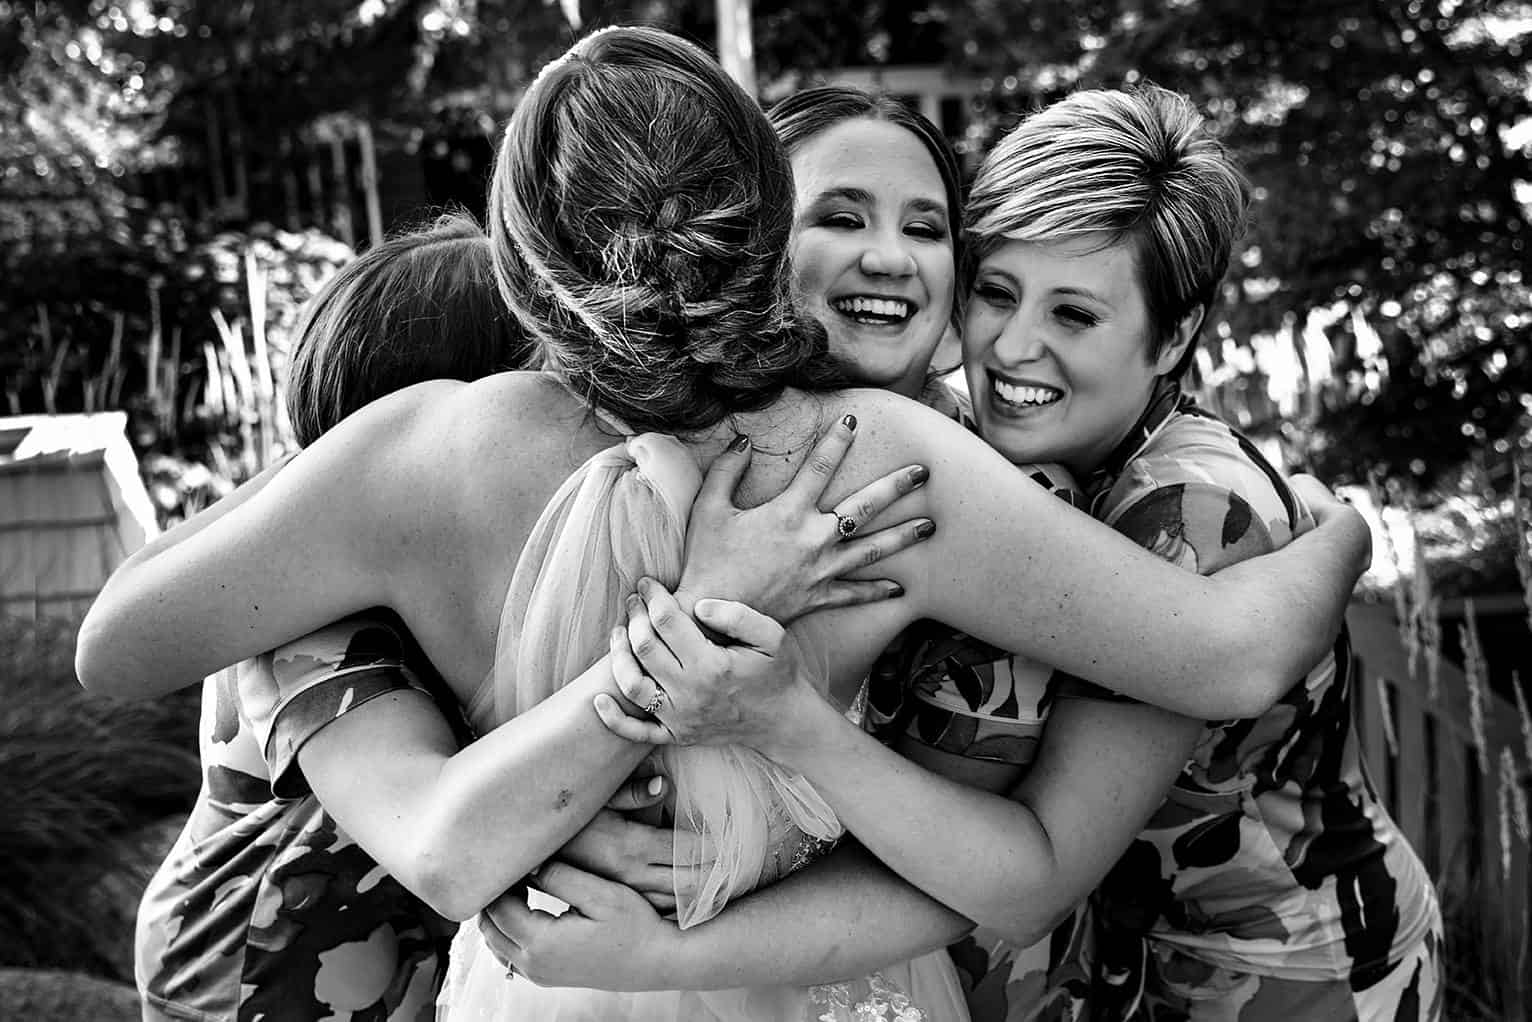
xmin=438 ymin=429 xmax=968 ymax=1022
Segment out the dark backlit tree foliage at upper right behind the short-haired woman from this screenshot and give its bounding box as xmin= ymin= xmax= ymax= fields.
xmin=953 ymin=0 xmax=1532 ymax=496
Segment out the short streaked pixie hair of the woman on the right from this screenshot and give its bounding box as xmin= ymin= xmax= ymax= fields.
xmin=965 ymin=86 xmax=1250 ymax=377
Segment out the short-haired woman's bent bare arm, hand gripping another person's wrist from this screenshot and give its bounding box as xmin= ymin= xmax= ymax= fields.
xmin=597 ymin=584 xmax=1203 ymax=945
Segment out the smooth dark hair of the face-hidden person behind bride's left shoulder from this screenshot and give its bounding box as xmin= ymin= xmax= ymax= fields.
xmin=286 ymin=213 xmax=532 ymax=446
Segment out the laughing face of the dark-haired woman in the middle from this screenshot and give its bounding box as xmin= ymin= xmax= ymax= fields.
xmin=792 ymin=120 xmax=956 ymax=397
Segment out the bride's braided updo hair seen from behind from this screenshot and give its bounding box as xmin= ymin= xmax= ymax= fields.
xmin=490 ymin=28 xmax=841 ymax=431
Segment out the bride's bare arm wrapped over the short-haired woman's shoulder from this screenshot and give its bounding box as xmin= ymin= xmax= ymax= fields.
xmin=821 ymin=397 xmax=1370 ymax=719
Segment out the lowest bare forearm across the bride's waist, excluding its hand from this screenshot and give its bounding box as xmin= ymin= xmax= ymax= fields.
xmin=659 ymin=843 xmax=973 ymax=990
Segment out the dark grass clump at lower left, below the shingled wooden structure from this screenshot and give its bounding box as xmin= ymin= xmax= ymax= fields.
xmin=0 ymin=617 xmax=199 ymax=979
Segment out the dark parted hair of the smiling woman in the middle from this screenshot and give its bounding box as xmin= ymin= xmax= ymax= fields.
xmin=766 ymin=86 xmax=970 ymax=329
